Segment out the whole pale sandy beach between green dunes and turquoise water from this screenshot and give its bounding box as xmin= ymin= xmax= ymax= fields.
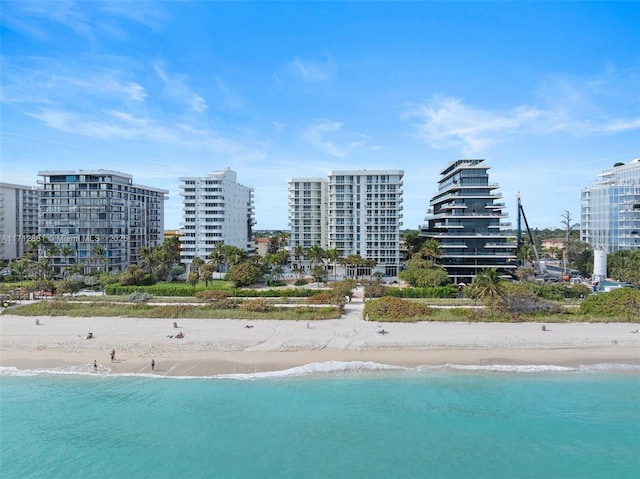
xmin=0 ymin=303 xmax=640 ymax=376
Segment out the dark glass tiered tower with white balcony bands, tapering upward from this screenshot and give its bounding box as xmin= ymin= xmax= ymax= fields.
xmin=421 ymin=159 xmax=516 ymax=284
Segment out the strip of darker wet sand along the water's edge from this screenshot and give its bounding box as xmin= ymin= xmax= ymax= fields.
xmin=0 ymin=348 xmax=640 ymax=377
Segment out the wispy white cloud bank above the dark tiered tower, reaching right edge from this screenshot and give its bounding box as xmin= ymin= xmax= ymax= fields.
xmin=402 ymin=68 xmax=640 ymax=156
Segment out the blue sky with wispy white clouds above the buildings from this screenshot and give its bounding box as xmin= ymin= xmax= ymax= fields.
xmin=0 ymin=0 xmax=640 ymax=229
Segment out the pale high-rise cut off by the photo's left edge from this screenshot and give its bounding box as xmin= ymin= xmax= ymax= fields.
xmin=0 ymin=183 xmax=38 ymax=261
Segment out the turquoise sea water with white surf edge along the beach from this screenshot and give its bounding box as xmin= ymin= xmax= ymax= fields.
xmin=0 ymin=363 xmax=640 ymax=478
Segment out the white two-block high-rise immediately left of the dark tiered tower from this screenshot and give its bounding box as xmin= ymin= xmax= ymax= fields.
xmin=288 ymin=170 xmax=404 ymax=277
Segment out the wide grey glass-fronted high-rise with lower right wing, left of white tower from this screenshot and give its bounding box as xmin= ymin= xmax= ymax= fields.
xmin=38 ymin=169 xmax=169 ymax=273
